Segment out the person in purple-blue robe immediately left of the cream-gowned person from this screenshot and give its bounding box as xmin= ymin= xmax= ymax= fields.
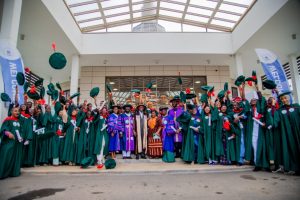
xmin=118 ymin=104 xmax=135 ymax=159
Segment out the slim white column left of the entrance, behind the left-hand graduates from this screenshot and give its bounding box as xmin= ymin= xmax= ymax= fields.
xmin=70 ymin=55 xmax=80 ymax=104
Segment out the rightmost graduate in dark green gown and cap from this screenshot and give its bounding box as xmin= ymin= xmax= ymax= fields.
xmin=275 ymin=92 xmax=300 ymax=175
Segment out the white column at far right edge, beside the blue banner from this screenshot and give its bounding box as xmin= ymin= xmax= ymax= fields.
xmin=289 ymin=54 xmax=300 ymax=103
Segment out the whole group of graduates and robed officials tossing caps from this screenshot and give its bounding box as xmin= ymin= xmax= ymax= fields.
xmin=0 ymin=70 xmax=300 ymax=179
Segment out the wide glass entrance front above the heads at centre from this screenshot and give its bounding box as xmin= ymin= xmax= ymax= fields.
xmin=106 ymin=76 xmax=207 ymax=108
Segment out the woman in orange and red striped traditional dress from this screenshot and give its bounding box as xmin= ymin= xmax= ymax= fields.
xmin=147 ymin=109 xmax=162 ymax=158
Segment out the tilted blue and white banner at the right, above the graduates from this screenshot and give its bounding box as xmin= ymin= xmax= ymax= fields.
xmin=255 ymin=49 xmax=290 ymax=94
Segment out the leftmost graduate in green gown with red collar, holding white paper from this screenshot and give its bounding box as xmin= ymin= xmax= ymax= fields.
xmin=0 ymin=107 xmax=24 ymax=179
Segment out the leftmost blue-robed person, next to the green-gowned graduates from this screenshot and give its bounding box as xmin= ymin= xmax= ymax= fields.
xmin=107 ymin=105 xmax=120 ymax=159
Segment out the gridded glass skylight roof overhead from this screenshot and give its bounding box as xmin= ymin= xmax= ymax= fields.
xmin=64 ymin=0 xmax=256 ymax=33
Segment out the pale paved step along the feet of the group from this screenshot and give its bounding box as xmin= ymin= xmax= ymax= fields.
xmin=22 ymin=159 xmax=253 ymax=174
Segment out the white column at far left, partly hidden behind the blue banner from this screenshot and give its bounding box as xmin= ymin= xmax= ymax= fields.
xmin=0 ymin=0 xmax=22 ymax=122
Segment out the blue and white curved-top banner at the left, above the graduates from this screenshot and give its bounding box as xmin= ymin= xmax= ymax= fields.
xmin=0 ymin=40 xmax=24 ymax=104
